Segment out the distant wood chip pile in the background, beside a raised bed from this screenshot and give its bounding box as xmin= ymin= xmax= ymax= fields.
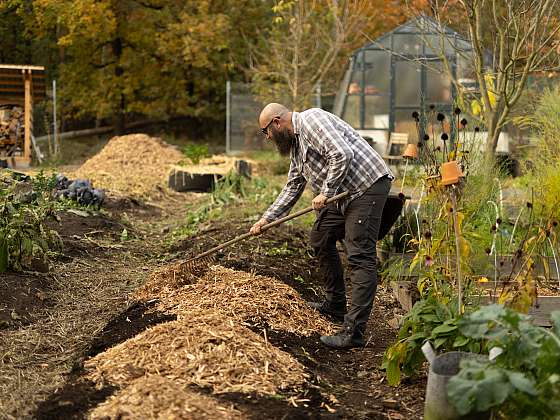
xmin=73 ymin=134 xmax=184 ymax=198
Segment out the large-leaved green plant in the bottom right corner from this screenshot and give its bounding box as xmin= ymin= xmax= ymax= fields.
xmin=447 ymin=305 xmax=560 ymax=419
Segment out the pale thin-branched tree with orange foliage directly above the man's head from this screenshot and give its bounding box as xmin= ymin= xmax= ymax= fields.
xmin=249 ymin=0 xmax=406 ymax=109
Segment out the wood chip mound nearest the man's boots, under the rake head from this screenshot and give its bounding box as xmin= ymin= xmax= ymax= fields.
xmin=134 ymin=264 xmax=333 ymax=336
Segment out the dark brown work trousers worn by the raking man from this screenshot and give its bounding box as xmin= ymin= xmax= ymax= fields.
xmin=310 ymin=177 xmax=391 ymax=334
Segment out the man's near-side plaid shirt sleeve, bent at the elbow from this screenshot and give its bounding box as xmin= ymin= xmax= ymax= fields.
xmin=310 ymin=111 xmax=354 ymax=198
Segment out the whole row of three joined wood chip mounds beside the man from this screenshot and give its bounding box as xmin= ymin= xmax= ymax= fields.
xmin=84 ymin=265 xmax=332 ymax=419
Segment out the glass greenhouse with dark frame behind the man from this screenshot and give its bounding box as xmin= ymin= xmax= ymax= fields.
xmin=334 ymin=16 xmax=477 ymax=154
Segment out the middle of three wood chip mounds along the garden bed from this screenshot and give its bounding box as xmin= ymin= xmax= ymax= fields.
xmin=84 ymin=310 xmax=307 ymax=395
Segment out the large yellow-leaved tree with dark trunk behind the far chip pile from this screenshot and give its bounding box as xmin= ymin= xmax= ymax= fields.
xmin=34 ymin=0 xmax=266 ymax=131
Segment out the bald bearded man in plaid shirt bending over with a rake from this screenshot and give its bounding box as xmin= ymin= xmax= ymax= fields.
xmin=250 ymin=103 xmax=393 ymax=349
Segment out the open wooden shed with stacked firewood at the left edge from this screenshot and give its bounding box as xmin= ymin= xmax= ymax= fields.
xmin=0 ymin=64 xmax=46 ymax=168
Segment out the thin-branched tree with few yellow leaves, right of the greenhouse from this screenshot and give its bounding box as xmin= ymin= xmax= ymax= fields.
xmin=432 ymin=0 xmax=560 ymax=157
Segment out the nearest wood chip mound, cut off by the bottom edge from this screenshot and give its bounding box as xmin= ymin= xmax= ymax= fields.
xmin=89 ymin=376 xmax=242 ymax=420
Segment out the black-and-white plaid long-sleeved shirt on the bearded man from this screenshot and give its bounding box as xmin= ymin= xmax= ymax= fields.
xmin=263 ymin=108 xmax=394 ymax=222
